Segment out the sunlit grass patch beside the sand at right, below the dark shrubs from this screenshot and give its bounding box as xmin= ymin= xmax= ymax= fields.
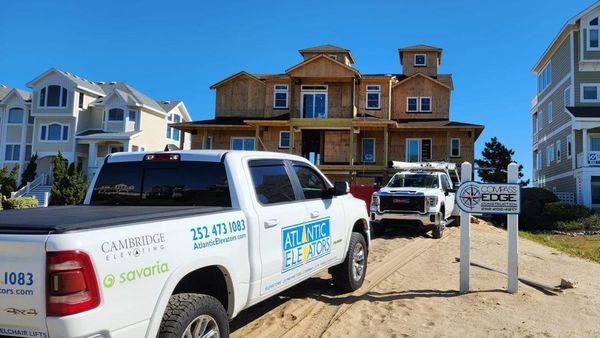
xmin=519 ymin=231 xmax=600 ymax=263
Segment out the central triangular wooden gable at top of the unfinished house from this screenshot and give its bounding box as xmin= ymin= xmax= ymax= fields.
xmin=285 ymin=54 xmax=361 ymax=77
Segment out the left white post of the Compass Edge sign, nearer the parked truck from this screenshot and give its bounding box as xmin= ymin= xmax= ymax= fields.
xmin=460 ymin=162 xmax=473 ymax=293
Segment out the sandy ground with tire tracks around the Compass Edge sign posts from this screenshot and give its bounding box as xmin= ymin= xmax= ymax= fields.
xmin=231 ymin=222 xmax=600 ymax=337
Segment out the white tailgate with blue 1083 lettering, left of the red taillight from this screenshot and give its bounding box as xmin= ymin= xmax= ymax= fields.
xmin=0 ymin=234 xmax=48 ymax=337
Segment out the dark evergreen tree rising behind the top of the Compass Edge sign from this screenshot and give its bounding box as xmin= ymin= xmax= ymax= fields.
xmin=475 ymin=137 xmax=529 ymax=186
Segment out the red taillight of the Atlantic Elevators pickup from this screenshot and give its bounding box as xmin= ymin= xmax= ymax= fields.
xmin=46 ymin=251 xmax=100 ymax=316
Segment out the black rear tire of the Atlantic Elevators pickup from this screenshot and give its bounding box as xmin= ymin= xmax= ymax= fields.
xmin=158 ymin=293 xmax=229 ymax=338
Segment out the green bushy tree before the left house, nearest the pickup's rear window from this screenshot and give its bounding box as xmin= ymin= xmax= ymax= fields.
xmin=50 ymin=152 xmax=87 ymax=205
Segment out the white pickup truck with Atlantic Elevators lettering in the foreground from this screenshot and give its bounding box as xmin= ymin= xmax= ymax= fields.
xmin=0 ymin=151 xmax=370 ymax=338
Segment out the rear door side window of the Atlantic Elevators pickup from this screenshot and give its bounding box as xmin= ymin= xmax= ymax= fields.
xmin=250 ymin=160 xmax=296 ymax=204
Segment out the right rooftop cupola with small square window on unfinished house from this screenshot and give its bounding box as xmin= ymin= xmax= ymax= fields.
xmin=398 ymin=45 xmax=442 ymax=76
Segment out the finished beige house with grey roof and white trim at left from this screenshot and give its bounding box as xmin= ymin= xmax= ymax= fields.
xmin=0 ymin=68 xmax=191 ymax=202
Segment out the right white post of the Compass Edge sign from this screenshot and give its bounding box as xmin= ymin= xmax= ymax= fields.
xmin=507 ymin=163 xmax=519 ymax=293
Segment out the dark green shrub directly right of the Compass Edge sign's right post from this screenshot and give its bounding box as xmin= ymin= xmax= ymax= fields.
xmin=519 ymin=188 xmax=560 ymax=230
